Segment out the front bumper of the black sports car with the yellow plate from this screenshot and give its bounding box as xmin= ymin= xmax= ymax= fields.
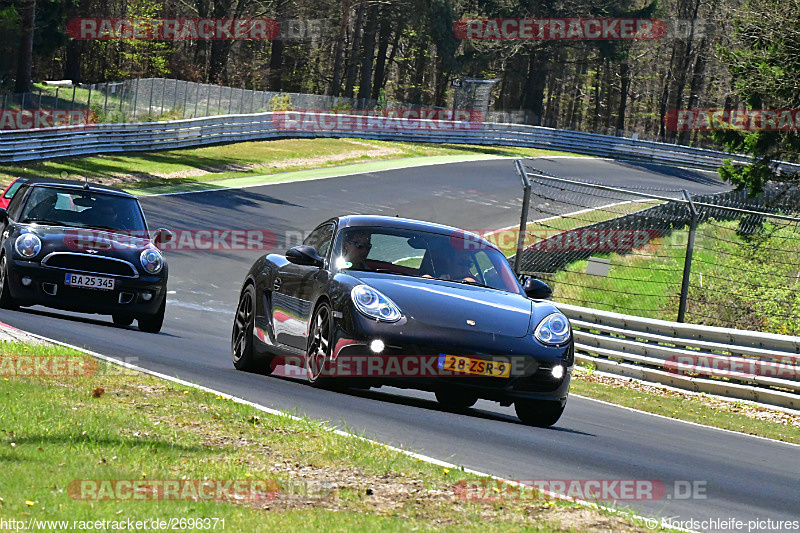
xmin=331 ymin=312 xmax=574 ymax=405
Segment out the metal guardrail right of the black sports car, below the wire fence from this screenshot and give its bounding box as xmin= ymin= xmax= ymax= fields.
xmin=556 ymin=303 xmax=800 ymax=409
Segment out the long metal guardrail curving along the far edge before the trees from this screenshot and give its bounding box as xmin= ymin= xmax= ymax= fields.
xmin=0 ymin=112 xmax=800 ymax=171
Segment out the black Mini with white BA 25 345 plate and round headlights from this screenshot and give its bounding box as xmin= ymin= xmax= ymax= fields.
xmin=0 ymin=179 xmax=171 ymax=333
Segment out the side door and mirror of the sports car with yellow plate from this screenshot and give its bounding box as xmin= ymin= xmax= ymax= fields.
xmin=272 ymin=222 xmax=336 ymax=350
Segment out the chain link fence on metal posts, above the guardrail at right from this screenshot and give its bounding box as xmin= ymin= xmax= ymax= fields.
xmin=515 ymin=159 xmax=800 ymax=335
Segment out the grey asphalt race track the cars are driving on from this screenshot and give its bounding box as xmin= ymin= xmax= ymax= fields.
xmin=0 ymin=158 xmax=800 ymax=527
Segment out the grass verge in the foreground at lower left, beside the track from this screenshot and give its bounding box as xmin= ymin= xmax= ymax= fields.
xmin=0 ymin=343 xmax=646 ymax=532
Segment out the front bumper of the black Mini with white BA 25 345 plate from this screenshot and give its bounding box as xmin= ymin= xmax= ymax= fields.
xmin=7 ymin=259 xmax=167 ymax=316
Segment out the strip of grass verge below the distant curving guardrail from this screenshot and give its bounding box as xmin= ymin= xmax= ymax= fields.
xmin=0 ymin=139 xmax=588 ymax=188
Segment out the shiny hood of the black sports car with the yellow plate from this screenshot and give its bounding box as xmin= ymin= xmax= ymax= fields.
xmin=350 ymin=272 xmax=533 ymax=337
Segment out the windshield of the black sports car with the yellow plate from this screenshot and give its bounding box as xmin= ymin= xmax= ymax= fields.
xmin=332 ymin=227 xmax=522 ymax=294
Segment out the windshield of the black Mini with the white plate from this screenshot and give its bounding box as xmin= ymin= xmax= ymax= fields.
xmin=20 ymin=186 xmax=147 ymax=234
